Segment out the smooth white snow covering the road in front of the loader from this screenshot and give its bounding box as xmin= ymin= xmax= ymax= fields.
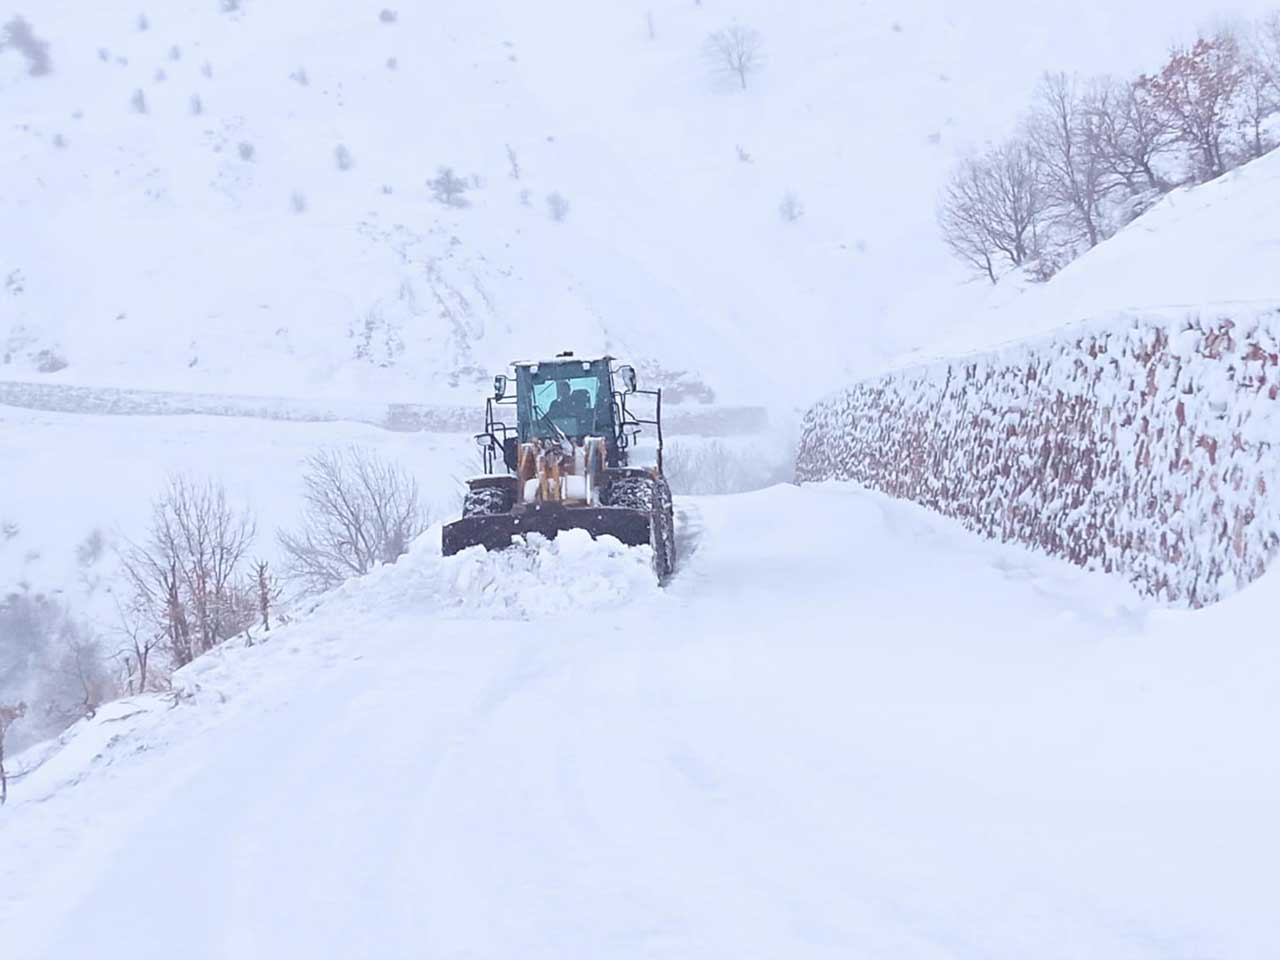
xmin=0 ymin=486 xmax=1280 ymax=960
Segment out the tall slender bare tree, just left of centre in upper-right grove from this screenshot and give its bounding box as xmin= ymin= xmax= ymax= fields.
xmin=1029 ymin=73 xmax=1116 ymax=247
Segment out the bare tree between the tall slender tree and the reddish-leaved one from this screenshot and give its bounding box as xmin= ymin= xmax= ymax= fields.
xmin=1085 ymin=81 xmax=1178 ymax=193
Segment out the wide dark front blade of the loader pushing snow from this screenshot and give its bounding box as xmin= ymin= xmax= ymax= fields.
xmin=442 ymin=503 xmax=652 ymax=557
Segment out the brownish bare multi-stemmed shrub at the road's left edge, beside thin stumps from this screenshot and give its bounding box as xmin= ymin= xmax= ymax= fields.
xmin=123 ymin=476 xmax=255 ymax=668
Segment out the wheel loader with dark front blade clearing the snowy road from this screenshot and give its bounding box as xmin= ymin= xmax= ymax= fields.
xmin=442 ymin=353 xmax=676 ymax=581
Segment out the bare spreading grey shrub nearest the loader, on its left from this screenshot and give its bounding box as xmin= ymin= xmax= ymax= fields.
xmin=278 ymin=447 xmax=429 ymax=593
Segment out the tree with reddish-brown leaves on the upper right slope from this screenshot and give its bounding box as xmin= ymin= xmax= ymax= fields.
xmin=1140 ymin=31 xmax=1243 ymax=180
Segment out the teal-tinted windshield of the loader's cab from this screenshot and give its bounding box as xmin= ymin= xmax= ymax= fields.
xmin=516 ymin=361 xmax=613 ymax=440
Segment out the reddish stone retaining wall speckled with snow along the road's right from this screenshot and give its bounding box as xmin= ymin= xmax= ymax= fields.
xmin=796 ymin=308 xmax=1280 ymax=607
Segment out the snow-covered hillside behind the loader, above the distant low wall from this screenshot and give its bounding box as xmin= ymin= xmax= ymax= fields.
xmin=0 ymin=0 xmax=1266 ymax=402
